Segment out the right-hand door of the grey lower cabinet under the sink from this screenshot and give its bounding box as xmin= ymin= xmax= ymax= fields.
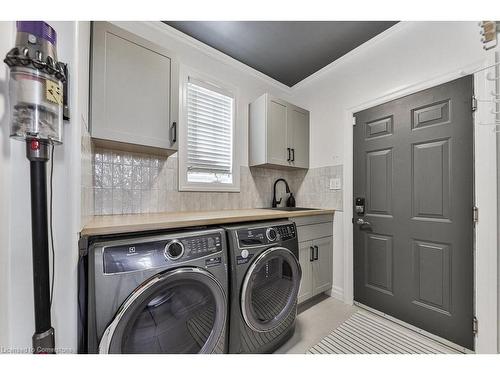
xmin=312 ymin=237 xmax=333 ymax=296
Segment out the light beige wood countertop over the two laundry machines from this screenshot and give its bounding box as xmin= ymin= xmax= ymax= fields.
xmin=81 ymin=208 xmax=335 ymax=236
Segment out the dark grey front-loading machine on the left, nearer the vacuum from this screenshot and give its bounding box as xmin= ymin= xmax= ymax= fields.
xmin=83 ymin=229 xmax=228 ymax=353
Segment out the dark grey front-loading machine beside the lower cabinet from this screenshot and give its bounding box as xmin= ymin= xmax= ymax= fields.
xmin=225 ymin=221 xmax=302 ymax=353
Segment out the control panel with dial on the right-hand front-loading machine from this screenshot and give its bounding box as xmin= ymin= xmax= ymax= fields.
xmin=237 ymin=223 xmax=297 ymax=248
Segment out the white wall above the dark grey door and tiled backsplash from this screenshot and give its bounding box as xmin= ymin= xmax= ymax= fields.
xmin=294 ymin=22 xmax=485 ymax=167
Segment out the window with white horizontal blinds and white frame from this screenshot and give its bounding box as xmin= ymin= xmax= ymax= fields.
xmin=179 ymin=73 xmax=239 ymax=191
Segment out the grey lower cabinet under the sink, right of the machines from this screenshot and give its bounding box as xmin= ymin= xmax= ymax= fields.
xmin=296 ymin=217 xmax=333 ymax=303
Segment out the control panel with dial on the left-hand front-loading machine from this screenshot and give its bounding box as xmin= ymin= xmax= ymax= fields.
xmin=103 ymin=232 xmax=223 ymax=274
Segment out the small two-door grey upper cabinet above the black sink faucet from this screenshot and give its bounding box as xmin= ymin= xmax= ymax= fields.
xmin=249 ymin=94 xmax=309 ymax=169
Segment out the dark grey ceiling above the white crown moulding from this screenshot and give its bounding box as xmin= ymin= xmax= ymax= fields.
xmin=164 ymin=21 xmax=396 ymax=86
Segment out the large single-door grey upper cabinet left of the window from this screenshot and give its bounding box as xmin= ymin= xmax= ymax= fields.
xmin=91 ymin=22 xmax=179 ymax=154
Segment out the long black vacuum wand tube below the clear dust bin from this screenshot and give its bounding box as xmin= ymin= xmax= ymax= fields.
xmin=26 ymin=140 xmax=55 ymax=354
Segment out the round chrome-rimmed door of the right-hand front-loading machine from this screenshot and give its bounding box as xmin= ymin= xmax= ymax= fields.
xmin=241 ymin=247 xmax=301 ymax=332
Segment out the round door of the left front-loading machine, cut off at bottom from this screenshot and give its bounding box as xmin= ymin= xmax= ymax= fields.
xmin=100 ymin=268 xmax=226 ymax=353
